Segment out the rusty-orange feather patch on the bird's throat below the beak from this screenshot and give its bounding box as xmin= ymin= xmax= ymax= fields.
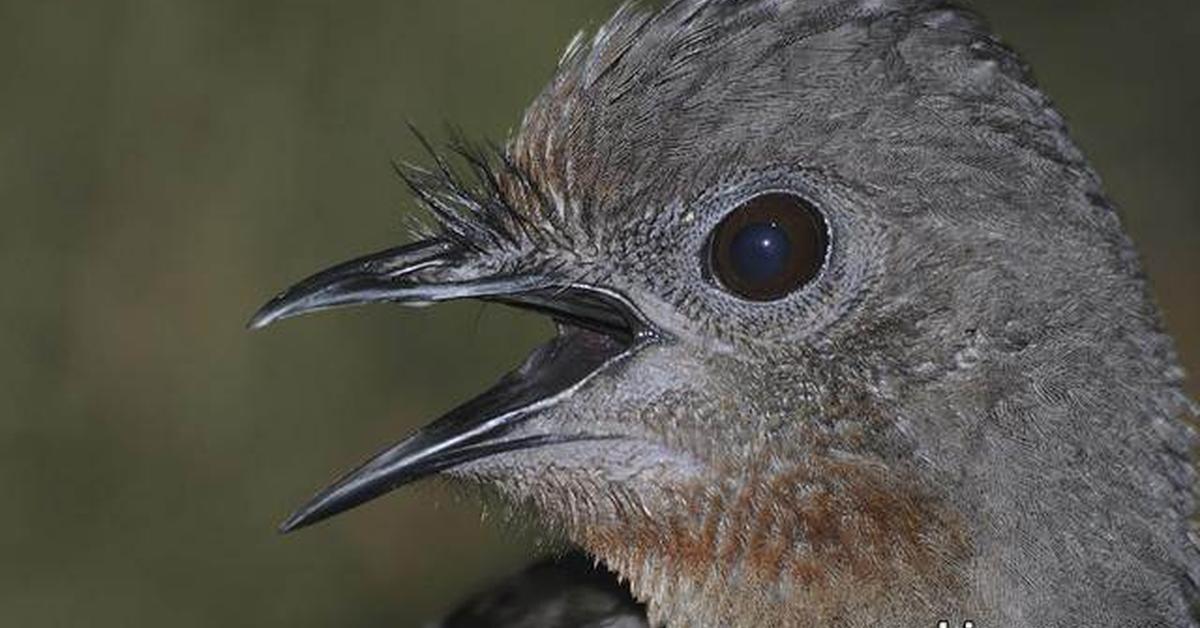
xmin=580 ymin=460 xmax=970 ymax=626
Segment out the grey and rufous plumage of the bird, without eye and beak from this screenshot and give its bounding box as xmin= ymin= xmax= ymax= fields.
xmin=255 ymin=0 xmax=1200 ymax=628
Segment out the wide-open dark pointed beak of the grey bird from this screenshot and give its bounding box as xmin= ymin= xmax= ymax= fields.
xmin=250 ymin=239 xmax=653 ymax=532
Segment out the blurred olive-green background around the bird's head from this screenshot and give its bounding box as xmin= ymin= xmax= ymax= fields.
xmin=0 ymin=0 xmax=1200 ymax=627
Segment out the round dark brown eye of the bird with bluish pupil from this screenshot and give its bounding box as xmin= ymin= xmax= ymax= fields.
xmin=709 ymin=193 xmax=829 ymax=301
